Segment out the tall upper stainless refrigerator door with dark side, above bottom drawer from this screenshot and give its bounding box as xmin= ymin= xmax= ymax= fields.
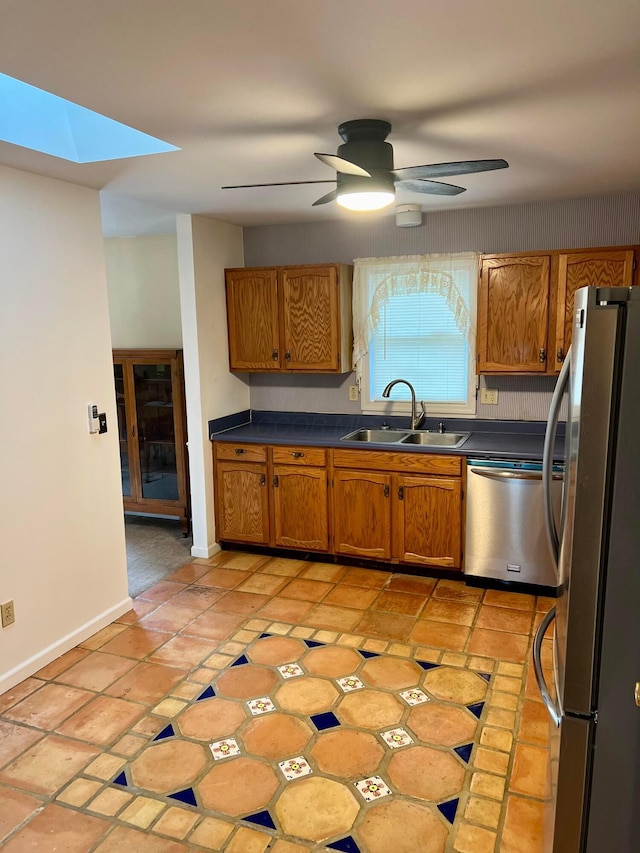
xmin=555 ymin=287 xmax=628 ymax=716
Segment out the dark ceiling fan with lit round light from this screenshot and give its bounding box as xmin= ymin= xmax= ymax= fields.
xmin=222 ymin=118 xmax=509 ymax=210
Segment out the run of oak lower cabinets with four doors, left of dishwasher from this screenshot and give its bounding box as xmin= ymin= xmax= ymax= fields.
xmin=214 ymin=442 xmax=464 ymax=569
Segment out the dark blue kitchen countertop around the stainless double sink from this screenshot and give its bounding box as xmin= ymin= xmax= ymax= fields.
xmin=209 ymin=411 xmax=564 ymax=462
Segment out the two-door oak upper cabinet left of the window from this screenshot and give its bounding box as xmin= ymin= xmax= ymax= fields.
xmin=225 ymin=264 xmax=353 ymax=373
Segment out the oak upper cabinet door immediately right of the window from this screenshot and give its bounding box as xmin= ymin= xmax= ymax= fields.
xmin=478 ymin=255 xmax=550 ymax=373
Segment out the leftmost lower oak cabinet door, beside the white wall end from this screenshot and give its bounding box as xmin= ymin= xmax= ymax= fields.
xmin=216 ymin=462 xmax=269 ymax=545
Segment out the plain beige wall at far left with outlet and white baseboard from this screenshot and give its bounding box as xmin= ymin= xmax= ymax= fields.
xmin=0 ymin=167 xmax=131 ymax=693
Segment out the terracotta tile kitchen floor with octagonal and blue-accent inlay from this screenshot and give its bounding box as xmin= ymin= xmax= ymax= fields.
xmin=0 ymin=551 xmax=551 ymax=853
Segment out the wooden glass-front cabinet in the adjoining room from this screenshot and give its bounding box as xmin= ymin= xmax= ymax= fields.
xmin=113 ymin=350 xmax=189 ymax=532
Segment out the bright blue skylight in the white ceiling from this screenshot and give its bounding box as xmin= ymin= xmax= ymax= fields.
xmin=0 ymin=74 xmax=180 ymax=163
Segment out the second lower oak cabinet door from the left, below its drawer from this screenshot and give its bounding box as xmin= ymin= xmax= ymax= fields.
xmin=273 ymin=465 xmax=329 ymax=551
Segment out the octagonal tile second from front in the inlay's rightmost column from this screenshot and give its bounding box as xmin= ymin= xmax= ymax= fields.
xmin=387 ymin=746 xmax=464 ymax=800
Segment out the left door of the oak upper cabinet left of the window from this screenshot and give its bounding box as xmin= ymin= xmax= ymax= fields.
xmin=226 ymin=269 xmax=281 ymax=371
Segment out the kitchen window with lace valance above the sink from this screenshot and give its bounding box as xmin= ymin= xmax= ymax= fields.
xmin=353 ymin=252 xmax=480 ymax=416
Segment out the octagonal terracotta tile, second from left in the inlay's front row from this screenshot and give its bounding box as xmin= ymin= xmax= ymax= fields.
xmin=198 ymin=756 xmax=280 ymax=817
